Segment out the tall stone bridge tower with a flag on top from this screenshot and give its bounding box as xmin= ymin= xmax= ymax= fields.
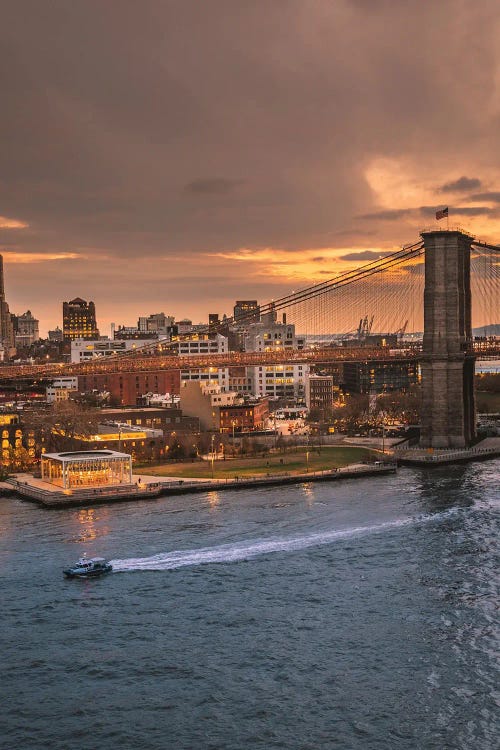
xmin=420 ymin=230 xmax=476 ymax=448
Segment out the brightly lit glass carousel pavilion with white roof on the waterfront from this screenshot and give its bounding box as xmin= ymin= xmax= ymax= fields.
xmin=42 ymin=450 xmax=132 ymax=490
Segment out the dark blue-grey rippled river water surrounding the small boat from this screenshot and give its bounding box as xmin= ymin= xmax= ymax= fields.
xmin=0 ymin=461 xmax=500 ymax=750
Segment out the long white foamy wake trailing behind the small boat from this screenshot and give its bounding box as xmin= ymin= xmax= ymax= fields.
xmin=110 ymin=508 xmax=456 ymax=573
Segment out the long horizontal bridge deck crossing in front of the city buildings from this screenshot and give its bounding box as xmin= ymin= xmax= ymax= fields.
xmin=0 ymin=341 xmax=500 ymax=383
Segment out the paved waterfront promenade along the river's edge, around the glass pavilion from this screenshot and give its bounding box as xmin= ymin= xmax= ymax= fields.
xmin=0 ymin=462 xmax=396 ymax=509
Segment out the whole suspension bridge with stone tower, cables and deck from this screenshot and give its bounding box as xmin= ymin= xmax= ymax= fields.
xmin=0 ymin=228 xmax=500 ymax=447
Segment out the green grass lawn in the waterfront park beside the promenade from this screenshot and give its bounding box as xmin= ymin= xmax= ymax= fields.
xmin=134 ymin=446 xmax=377 ymax=479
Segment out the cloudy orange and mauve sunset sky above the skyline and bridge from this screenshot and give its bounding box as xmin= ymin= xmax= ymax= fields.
xmin=0 ymin=0 xmax=500 ymax=335
